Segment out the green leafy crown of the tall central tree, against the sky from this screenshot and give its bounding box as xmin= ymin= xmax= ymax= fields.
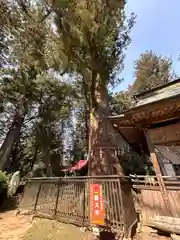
xmin=39 ymin=0 xmax=135 ymax=112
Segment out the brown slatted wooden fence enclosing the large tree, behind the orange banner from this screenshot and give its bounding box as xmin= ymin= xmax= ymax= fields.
xmin=19 ymin=176 xmax=136 ymax=233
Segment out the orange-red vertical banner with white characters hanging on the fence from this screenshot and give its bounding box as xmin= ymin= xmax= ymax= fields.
xmin=90 ymin=184 xmax=104 ymax=225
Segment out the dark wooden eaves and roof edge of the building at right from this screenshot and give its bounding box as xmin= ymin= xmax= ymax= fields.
xmin=109 ymin=79 xmax=180 ymax=155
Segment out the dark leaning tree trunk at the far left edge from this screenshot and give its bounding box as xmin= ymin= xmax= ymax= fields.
xmin=0 ymin=107 xmax=25 ymax=170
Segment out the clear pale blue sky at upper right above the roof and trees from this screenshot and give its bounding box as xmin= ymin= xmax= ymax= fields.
xmin=116 ymin=0 xmax=180 ymax=91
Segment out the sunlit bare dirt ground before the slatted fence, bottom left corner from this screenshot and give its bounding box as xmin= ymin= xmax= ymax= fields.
xmin=0 ymin=211 xmax=92 ymax=240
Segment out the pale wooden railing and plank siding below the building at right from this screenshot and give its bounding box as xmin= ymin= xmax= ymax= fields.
xmin=131 ymin=176 xmax=180 ymax=233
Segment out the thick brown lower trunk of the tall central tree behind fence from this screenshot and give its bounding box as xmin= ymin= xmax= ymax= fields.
xmin=88 ymin=81 xmax=129 ymax=176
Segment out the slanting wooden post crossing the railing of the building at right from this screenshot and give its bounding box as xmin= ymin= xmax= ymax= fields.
xmin=144 ymin=129 xmax=174 ymax=215
